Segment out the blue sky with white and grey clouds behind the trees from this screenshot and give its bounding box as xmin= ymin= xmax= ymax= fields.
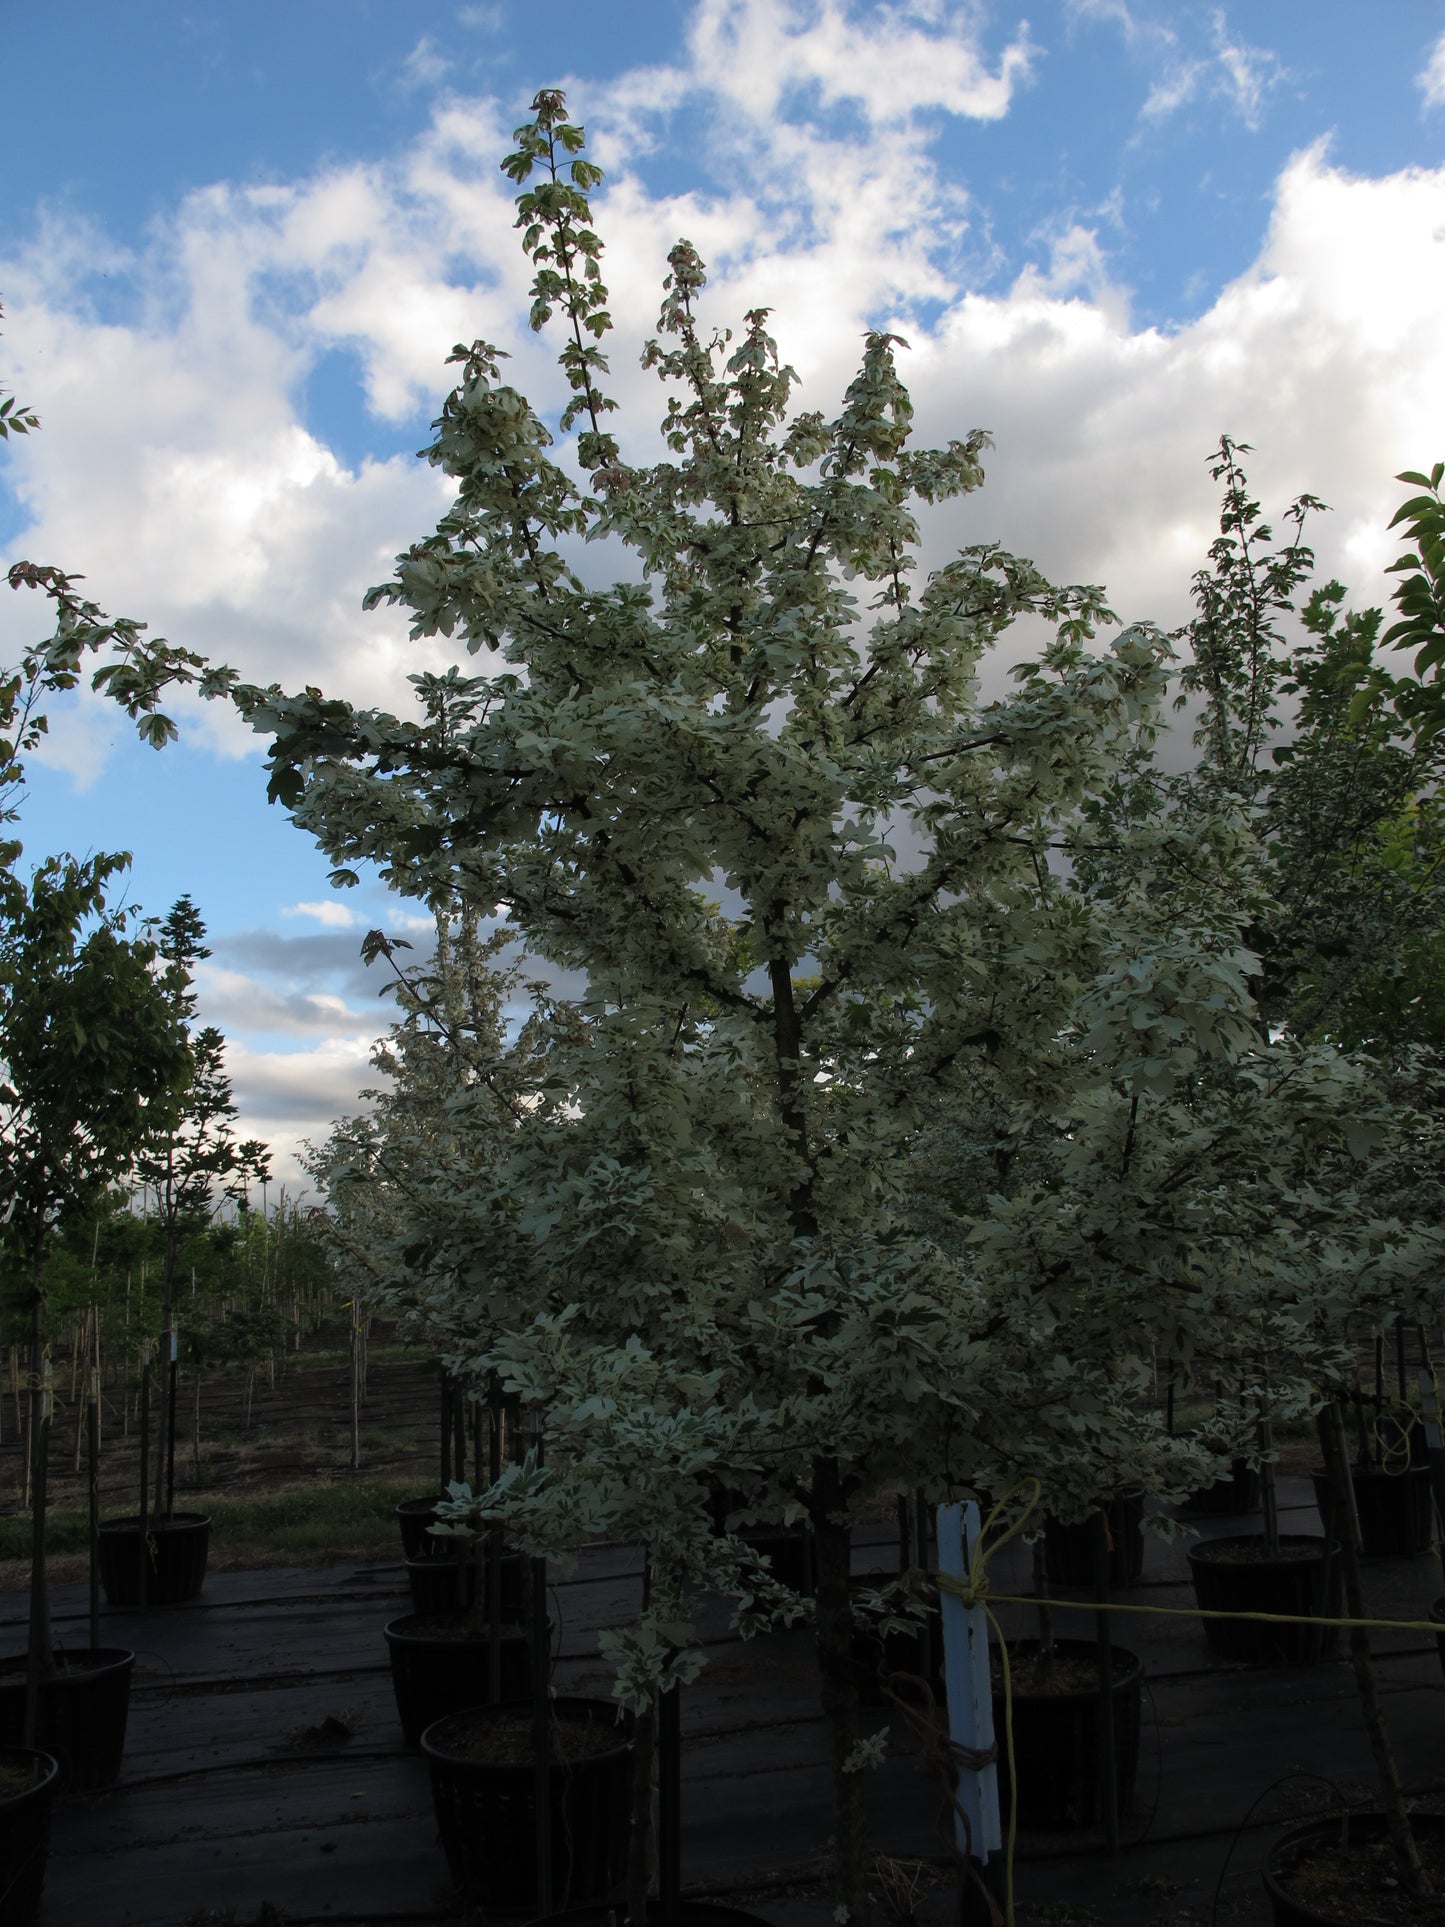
xmin=0 ymin=0 xmax=1445 ymax=1179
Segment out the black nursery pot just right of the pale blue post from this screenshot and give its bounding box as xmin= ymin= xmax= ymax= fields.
xmin=994 ymin=1640 xmax=1144 ymax=1833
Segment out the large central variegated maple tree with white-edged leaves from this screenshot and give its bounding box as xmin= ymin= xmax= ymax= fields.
xmin=235 ymin=92 xmax=1441 ymax=1921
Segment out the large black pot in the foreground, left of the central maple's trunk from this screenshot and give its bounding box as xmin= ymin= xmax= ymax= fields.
xmin=422 ymin=1698 xmax=632 ymax=1910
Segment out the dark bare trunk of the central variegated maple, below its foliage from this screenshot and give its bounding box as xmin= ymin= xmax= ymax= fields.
xmin=811 ymin=1459 xmax=871 ymax=1927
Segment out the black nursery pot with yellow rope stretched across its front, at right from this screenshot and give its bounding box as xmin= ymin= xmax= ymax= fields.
xmin=1189 ymin=1532 xmax=1341 ymax=1665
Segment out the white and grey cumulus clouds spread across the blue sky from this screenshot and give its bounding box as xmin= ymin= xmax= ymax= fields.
xmin=0 ymin=0 xmax=1445 ymax=1163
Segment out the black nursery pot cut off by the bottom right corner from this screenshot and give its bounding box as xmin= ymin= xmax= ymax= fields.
xmin=1264 ymin=1809 xmax=1445 ymax=1927
